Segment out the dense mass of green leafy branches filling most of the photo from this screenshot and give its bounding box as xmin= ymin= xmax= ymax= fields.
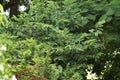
xmin=0 ymin=0 xmax=119 ymax=80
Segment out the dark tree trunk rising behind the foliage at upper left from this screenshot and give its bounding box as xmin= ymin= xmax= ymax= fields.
xmin=10 ymin=0 xmax=20 ymax=17
